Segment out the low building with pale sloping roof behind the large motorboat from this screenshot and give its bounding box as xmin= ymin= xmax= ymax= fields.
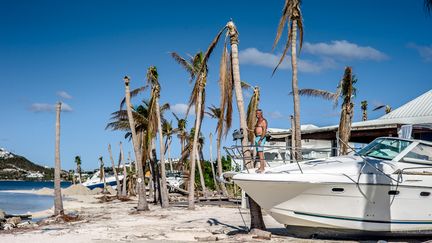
xmin=269 ymin=90 xmax=432 ymax=158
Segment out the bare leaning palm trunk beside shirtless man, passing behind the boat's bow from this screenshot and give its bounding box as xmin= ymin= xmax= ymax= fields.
xmin=227 ymin=21 xmax=266 ymax=230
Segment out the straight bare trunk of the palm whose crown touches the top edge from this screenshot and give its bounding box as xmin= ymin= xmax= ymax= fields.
xmin=291 ymin=19 xmax=302 ymax=160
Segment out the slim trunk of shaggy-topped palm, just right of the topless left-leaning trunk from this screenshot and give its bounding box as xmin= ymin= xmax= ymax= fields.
xmin=156 ymin=94 xmax=169 ymax=208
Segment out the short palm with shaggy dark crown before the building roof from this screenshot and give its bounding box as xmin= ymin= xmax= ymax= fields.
xmin=299 ymin=67 xmax=357 ymax=155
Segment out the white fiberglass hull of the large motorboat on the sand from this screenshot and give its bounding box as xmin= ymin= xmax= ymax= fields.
xmin=233 ymin=174 xmax=432 ymax=233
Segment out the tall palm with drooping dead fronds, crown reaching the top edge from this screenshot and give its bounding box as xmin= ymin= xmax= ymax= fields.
xmin=273 ymin=0 xmax=303 ymax=160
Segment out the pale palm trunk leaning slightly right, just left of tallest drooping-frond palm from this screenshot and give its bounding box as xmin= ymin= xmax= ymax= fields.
xmin=188 ymin=82 xmax=204 ymax=210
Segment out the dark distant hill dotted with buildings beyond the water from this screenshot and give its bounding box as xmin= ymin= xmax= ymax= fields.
xmin=0 ymin=148 xmax=54 ymax=180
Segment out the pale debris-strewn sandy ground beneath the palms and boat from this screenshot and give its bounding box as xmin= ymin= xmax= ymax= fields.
xmin=0 ymin=187 xmax=426 ymax=243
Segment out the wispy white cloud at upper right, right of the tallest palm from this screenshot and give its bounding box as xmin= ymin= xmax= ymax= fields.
xmin=303 ymin=40 xmax=388 ymax=61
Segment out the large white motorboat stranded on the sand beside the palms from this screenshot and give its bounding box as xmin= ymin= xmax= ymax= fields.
xmin=231 ymin=137 xmax=432 ymax=236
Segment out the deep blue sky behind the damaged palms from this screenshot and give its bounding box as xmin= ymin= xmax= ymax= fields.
xmin=0 ymin=0 xmax=432 ymax=169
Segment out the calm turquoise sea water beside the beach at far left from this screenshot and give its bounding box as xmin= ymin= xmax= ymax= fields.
xmin=0 ymin=181 xmax=71 ymax=214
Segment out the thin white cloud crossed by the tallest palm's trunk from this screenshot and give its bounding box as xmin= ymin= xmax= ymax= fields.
xmin=239 ymin=48 xmax=335 ymax=72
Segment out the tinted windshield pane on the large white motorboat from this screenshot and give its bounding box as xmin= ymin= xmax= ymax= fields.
xmin=358 ymin=138 xmax=412 ymax=160
